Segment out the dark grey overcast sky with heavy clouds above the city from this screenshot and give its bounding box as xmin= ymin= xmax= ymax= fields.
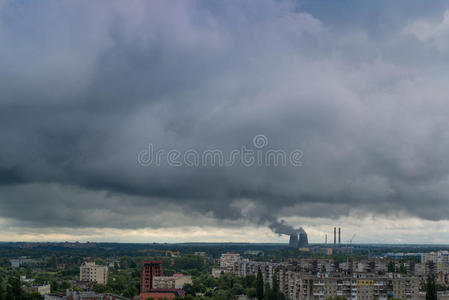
xmin=0 ymin=0 xmax=449 ymax=243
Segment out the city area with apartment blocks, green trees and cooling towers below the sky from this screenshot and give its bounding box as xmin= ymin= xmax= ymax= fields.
xmin=0 ymin=228 xmax=449 ymax=300
